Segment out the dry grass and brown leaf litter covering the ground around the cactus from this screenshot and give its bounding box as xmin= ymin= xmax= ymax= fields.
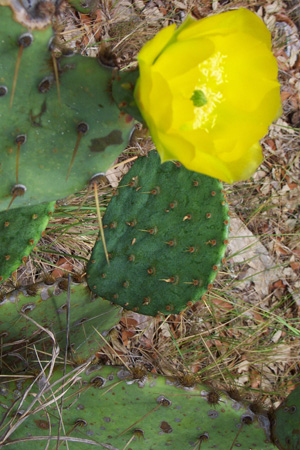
xmin=2 ymin=0 xmax=300 ymax=414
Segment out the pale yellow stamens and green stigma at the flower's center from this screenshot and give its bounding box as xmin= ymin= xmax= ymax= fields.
xmin=190 ymin=52 xmax=227 ymax=132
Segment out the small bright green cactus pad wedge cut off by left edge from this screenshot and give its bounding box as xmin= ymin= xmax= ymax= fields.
xmin=0 ymin=202 xmax=55 ymax=283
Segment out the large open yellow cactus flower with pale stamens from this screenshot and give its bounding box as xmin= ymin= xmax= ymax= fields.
xmin=134 ymin=8 xmax=281 ymax=183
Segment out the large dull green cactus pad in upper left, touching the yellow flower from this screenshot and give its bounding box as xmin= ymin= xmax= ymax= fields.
xmin=0 ymin=7 xmax=133 ymax=210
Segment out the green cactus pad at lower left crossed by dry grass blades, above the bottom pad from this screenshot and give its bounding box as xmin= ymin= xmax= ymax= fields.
xmin=0 ymin=278 xmax=121 ymax=364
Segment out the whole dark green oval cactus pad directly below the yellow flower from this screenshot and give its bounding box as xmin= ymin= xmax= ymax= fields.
xmin=87 ymin=151 xmax=229 ymax=315
